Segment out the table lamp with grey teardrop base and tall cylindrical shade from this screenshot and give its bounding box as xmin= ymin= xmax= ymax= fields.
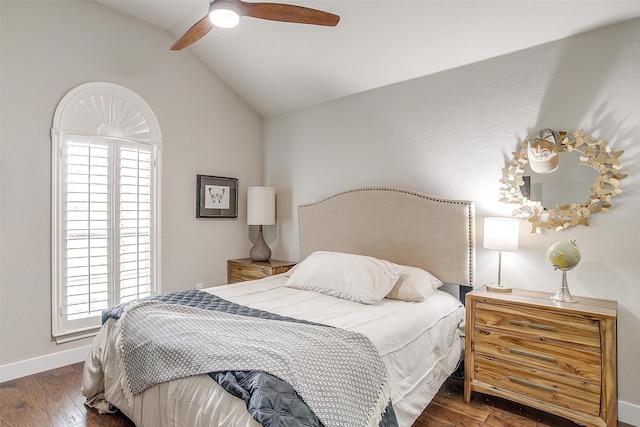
xmin=247 ymin=187 xmax=276 ymax=261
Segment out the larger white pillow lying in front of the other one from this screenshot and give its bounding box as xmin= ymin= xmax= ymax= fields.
xmin=285 ymin=251 xmax=401 ymax=304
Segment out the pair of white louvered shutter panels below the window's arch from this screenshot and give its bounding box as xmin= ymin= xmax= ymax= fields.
xmin=60 ymin=137 xmax=159 ymax=336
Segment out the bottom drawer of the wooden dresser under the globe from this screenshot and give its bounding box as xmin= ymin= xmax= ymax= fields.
xmin=475 ymin=356 xmax=600 ymax=415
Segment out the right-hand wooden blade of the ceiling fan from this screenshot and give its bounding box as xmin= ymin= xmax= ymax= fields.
xmin=239 ymin=0 xmax=340 ymax=27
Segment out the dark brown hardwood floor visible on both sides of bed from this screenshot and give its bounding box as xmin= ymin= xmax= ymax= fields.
xmin=0 ymin=363 xmax=631 ymax=427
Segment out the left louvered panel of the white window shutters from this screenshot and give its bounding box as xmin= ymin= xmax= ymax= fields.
xmin=60 ymin=142 xmax=113 ymax=329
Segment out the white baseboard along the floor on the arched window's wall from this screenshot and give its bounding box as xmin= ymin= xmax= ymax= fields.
xmin=0 ymin=345 xmax=91 ymax=383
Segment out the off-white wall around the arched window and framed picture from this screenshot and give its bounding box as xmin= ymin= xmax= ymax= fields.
xmin=0 ymin=0 xmax=261 ymax=372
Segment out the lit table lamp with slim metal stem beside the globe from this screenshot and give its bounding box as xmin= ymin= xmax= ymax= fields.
xmin=483 ymin=218 xmax=520 ymax=292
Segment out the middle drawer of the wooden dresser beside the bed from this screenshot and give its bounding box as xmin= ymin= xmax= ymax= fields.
xmin=473 ymin=327 xmax=601 ymax=384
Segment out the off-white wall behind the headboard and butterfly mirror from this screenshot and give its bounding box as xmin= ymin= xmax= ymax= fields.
xmin=263 ymin=20 xmax=640 ymax=425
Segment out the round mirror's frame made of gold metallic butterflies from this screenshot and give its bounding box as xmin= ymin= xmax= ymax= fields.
xmin=500 ymin=129 xmax=627 ymax=233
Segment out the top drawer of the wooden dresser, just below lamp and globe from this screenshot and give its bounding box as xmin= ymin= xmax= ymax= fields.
xmin=475 ymin=302 xmax=600 ymax=349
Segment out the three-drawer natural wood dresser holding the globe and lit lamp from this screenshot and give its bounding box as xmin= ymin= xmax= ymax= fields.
xmin=464 ymin=286 xmax=617 ymax=427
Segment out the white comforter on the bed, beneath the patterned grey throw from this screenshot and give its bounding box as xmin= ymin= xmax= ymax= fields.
xmin=83 ymin=275 xmax=464 ymax=427
